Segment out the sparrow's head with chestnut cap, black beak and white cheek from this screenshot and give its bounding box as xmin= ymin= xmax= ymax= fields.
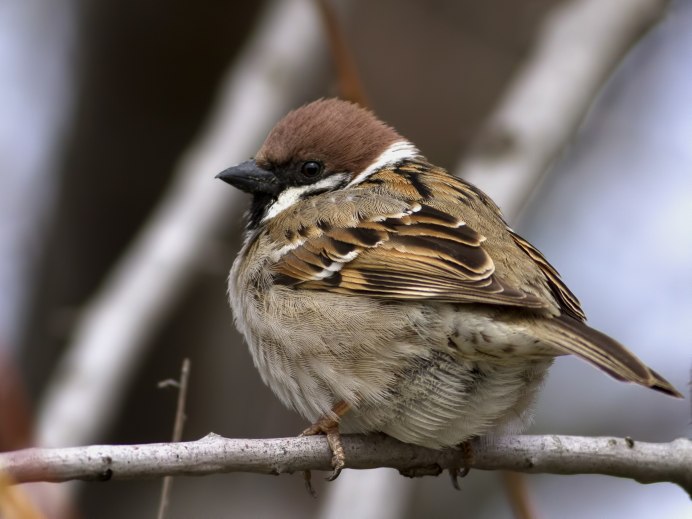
xmin=217 ymin=99 xmax=419 ymax=226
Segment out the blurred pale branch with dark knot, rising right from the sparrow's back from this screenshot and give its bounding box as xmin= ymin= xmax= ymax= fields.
xmin=456 ymin=0 xmax=669 ymax=219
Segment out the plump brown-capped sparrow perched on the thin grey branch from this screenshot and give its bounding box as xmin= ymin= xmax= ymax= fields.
xmin=217 ymin=99 xmax=682 ymax=479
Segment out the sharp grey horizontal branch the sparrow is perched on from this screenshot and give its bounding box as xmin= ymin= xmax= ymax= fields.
xmin=0 ymin=433 xmax=692 ymax=495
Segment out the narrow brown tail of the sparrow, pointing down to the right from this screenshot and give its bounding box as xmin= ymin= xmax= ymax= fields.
xmin=544 ymin=315 xmax=682 ymax=398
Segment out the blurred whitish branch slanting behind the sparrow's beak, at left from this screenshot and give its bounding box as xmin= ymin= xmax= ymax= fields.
xmin=36 ymin=0 xmax=324 ymax=446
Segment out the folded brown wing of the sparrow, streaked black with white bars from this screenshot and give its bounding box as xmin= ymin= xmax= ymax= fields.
xmin=274 ymin=204 xmax=547 ymax=308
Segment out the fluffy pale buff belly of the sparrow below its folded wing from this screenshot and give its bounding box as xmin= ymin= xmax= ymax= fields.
xmin=232 ymin=276 xmax=552 ymax=448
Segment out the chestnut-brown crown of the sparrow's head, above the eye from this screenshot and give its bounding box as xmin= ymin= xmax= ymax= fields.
xmin=255 ymin=99 xmax=403 ymax=173
